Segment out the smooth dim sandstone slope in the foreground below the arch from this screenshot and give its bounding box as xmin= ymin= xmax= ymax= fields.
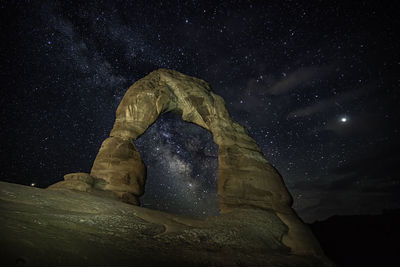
xmin=0 ymin=182 xmax=331 ymax=266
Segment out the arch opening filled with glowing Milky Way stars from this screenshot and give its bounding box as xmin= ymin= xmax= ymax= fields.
xmin=135 ymin=113 xmax=218 ymax=217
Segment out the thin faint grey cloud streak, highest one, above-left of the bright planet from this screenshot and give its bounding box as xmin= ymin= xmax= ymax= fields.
xmin=267 ymin=66 xmax=331 ymax=95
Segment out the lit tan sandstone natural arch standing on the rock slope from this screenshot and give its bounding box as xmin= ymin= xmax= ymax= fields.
xmin=47 ymin=69 xmax=332 ymax=264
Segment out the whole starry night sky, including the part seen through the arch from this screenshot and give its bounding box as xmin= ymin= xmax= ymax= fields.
xmin=0 ymin=0 xmax=400 ymax=222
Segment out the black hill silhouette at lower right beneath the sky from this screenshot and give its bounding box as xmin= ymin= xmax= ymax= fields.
xmin=310 ymin=210 xmax=400 ymax=267
